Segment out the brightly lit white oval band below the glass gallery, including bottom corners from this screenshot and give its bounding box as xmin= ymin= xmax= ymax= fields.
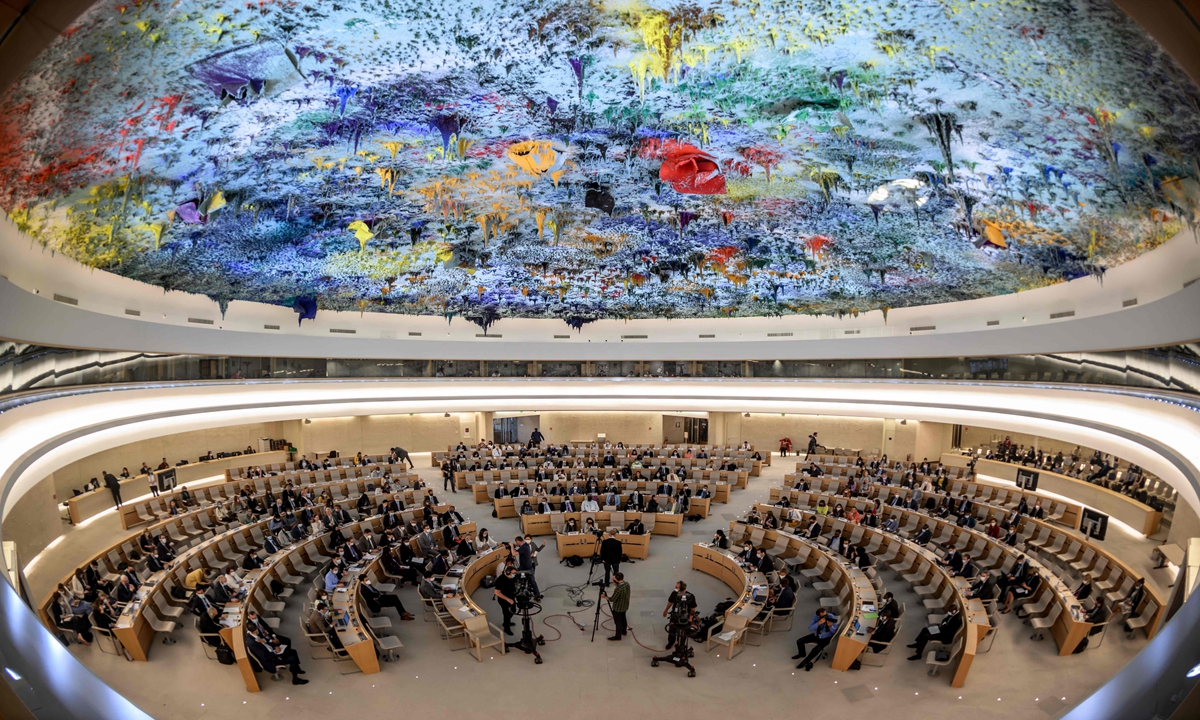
xmin=0 ymin=379 xmax=1200 ymax=720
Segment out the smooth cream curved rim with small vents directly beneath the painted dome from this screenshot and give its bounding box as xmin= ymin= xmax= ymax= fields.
xmin=0 ymin=278 xmax=1200 ymax=361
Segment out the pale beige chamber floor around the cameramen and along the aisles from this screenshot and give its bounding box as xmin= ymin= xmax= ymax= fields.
xmin=29 ymin=455 xmax=1172 ymax=720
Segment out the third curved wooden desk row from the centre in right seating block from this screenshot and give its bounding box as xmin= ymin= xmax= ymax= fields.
xmin=730 ymin=504 xmax=991 ymax=688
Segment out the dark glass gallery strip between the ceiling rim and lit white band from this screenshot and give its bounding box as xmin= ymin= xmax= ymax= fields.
xmin=0 ymin=342 xmax=1200 ymax=395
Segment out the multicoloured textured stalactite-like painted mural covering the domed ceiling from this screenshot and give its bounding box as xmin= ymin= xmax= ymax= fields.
xmin=0 ymin=0 xmax=1200 ymax=329
